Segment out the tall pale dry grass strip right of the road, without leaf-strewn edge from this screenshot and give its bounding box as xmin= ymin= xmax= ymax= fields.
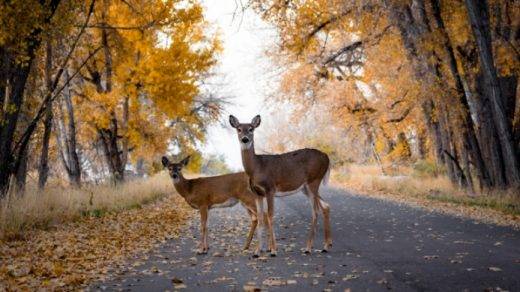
xmin=333 ymin=163 xmax=520 ymax=216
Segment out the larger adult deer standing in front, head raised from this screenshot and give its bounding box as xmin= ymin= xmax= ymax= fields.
xmin=229 ymin=115 xmax=332 ymax=256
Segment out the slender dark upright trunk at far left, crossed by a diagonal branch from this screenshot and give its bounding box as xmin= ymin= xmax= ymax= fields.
xmin=38 ymin=41 xmax=53 ymax=189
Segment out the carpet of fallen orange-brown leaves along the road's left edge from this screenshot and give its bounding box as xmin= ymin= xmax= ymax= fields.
xmin=0 ymin=195 xmax=193 ymax=291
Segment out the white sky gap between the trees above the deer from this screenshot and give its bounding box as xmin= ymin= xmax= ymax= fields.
xmin=201 ymin=0 xmax=277 ymax=170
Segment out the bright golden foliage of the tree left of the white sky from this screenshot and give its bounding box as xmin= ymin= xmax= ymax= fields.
xmin=74 ymin=0 xmax=221 ymax=161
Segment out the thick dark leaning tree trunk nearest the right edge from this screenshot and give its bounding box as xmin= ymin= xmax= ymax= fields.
xmin=465 ymin=0 xmax=520 ymax=187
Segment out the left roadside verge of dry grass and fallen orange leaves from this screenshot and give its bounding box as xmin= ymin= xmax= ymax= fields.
xmin=0 ymin=176 xmax=192 ymax=291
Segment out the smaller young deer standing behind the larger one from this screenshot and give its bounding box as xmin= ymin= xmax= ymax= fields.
xmin=161 ymin=156 xmax=265 ymax=255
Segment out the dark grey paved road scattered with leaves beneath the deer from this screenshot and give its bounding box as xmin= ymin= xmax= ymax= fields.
xmin=91 ymin=188 xmax=520 ymax=291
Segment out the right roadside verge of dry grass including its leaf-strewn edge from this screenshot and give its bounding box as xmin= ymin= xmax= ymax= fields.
xmin=332 ymin=165 xmax=520 ymax=228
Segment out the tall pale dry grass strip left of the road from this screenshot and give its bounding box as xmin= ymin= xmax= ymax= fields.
xmin=0 ymin=173 xmax=173 ymax=240
